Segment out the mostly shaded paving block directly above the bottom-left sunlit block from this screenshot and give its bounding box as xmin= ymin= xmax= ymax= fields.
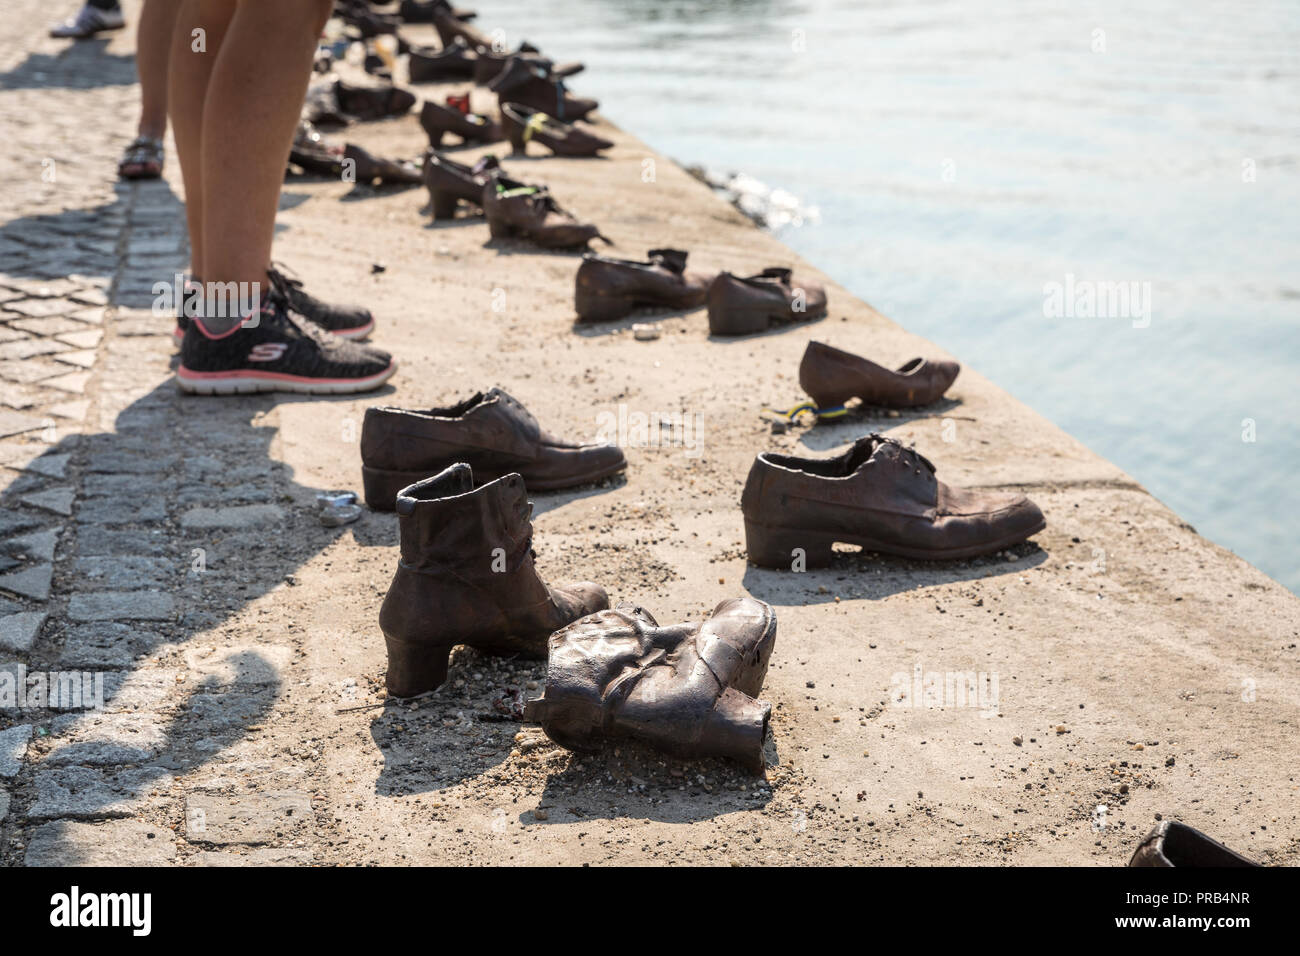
xmin=27 ymin=767 xmax=173 ymax=819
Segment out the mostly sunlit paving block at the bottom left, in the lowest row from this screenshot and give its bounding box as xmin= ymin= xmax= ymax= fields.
xmin=23 ymin=819 xmax=176 ymax=866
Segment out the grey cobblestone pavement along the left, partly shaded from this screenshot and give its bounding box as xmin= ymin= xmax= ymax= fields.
xmin=0 ymin=0 xmax=312 ymax=865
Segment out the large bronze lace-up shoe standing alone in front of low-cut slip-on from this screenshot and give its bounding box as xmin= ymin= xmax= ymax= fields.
xmin=741 ymin=434 xmax=1047 ymax=568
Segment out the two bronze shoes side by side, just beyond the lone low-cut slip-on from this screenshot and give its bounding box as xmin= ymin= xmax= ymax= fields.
xmin=573 ymin=248 xmax=826 ymax=336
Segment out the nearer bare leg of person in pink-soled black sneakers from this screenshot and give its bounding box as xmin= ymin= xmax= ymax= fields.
xmin=200 ymin=0 xmax=333 ymax=299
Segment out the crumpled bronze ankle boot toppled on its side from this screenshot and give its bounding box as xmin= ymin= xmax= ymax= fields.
xmin=524 ymin=597 xmax=776 ymax=774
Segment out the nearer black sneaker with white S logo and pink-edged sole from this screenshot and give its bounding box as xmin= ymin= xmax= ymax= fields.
xmin=176 ymin=294 xmax=397 ymax=395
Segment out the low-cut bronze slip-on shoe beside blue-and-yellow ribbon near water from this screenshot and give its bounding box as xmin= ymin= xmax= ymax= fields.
xmin=800 ymin=342 xmax=962 ymax=408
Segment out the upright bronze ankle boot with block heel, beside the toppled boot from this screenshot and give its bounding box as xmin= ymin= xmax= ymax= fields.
xmin=380 ymin=463 xmax=610 ymax=697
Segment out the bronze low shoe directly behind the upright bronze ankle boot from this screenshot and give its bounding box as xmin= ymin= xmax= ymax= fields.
xmin=361 ymin=389 xmax=628 ymax=511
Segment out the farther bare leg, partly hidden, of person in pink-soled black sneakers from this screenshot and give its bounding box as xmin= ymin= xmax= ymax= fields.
xmin=166 ymin=0 xmax=235 ymax=277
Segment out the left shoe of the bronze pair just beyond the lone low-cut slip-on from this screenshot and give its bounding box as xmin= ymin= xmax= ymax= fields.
xmin=573 ymin=248 xmax=711 ymax=323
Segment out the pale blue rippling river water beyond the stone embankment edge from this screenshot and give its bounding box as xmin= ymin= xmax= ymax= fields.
xmin=480 ymin=0 xmax=1300 ymax=592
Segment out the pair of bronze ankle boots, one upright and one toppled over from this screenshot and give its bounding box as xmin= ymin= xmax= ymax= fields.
xmin=380 ymin=463 xmax=776 ymax=773
